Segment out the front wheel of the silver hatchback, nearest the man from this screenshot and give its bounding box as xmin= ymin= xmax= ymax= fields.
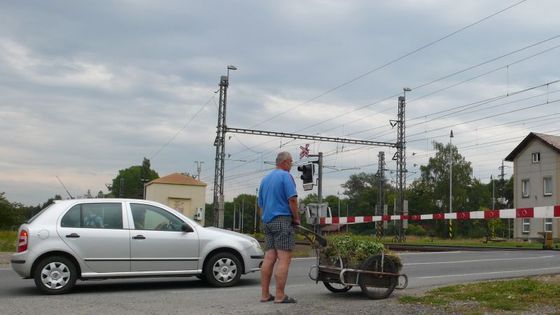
xmin=204 ymin=252 xmax=241 ymax=287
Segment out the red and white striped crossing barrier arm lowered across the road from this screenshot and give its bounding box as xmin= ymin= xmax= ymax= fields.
xmin=320 ymin=205 xmax=560 ymax=224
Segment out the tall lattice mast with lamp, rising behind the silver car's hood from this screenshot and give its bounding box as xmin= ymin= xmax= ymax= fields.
xmin=214 ymin=66 xmax=237 ymax=228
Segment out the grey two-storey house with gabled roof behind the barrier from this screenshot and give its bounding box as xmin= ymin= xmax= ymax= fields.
xmin=505 ymin=132 xmax=560 ymax=240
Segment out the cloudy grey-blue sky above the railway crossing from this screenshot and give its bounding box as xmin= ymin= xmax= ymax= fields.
xmin=0 ymin=0 xmax=560 ymax=205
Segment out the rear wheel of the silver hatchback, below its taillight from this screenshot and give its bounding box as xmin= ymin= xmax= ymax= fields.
xmin=33 ymin=256 xmax=78 ymax=294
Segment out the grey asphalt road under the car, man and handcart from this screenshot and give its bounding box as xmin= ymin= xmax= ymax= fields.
xmin=0 ymin=251 xmax=560 ymax=315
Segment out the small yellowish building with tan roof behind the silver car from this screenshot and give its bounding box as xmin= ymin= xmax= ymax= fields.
xmin=144 ymin=173 xmax=206 ymax=225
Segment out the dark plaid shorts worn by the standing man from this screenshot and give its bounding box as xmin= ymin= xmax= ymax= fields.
xmin=264 ymin=216 xmax=296 ymax=250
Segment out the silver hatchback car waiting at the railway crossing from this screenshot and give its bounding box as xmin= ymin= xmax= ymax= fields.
xmin=11 ymin=199 xmax=264 ymax=294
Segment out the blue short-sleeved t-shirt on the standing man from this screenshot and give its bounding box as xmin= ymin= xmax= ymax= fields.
xmin=259 ymin=169 xmax=297 ymax=223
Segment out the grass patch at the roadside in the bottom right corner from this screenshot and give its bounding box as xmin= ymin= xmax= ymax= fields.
xmin=399 ymin=275 xmax=560 ymax=314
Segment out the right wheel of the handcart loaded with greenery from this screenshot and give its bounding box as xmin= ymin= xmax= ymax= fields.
xmin=358 ymin=255 xmax=399 ymax=300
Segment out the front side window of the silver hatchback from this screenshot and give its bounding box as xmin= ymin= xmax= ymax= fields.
xmin=130 ymin=203 xmax=185 ymax=231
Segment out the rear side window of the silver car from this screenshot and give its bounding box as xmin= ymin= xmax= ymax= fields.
xmin=60 ymin=203 xmax=123 ymax=229
